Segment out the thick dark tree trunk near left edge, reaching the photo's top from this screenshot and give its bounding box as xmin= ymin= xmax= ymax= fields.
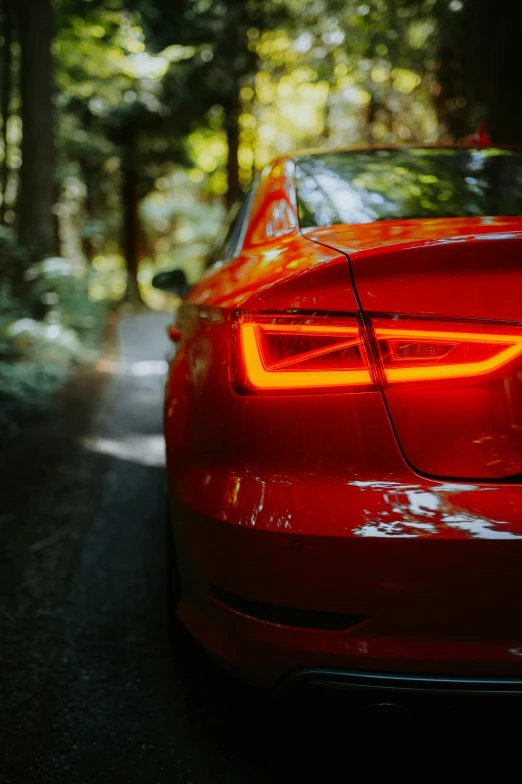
xmin=15 ymin=0 xmax=56 ymax=257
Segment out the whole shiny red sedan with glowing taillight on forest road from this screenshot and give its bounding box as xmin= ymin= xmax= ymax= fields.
xmin=157 ymin=145 xmax=522 ymax=692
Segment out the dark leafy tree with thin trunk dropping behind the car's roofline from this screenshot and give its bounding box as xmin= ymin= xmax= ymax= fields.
xmin=130 ymin=0 xmax=294 ymax=203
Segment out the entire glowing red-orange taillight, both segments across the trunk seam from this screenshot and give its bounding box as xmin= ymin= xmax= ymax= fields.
xmin=235 ymin=315 xmax=522 ymax=392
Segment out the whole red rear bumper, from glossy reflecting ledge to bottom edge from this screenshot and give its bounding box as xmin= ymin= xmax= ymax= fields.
xmin=171 ymin=462 xmax=522 ymax=692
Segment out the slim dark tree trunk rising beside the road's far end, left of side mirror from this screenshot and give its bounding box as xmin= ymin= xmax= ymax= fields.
xmin=121 ymin=139 xmax=141 ymax=302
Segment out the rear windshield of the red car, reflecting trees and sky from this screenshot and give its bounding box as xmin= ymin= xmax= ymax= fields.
xmin=296 ymin=148 xmax=522 ymax=228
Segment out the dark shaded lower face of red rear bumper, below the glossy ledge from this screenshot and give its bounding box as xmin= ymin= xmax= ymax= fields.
xmin=173 ymin=508 xmax=522 ymax=685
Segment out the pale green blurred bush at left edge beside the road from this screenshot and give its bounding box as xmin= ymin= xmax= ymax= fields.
xmin=0 ymin=242 xmax=107 ymax=434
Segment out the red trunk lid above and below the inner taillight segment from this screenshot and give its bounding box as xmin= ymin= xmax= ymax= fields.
xmin=309 ymin=218 xmax=522 ymax=481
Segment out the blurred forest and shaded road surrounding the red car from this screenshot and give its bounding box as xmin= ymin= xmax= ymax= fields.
xmin=0 ymin=0 xmax=522 ymax=784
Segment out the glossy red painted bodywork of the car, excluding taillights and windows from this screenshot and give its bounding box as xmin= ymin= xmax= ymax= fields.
xmin=165 ymin=150 xmax=522 ymax=686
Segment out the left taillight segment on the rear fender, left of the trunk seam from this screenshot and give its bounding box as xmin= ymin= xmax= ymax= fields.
xmin=236 ymin=316 xmax=373 ymax=392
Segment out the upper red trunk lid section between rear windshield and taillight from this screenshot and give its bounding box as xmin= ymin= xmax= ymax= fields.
xmin=307 ymin=218 xmax=522 ymax=321
